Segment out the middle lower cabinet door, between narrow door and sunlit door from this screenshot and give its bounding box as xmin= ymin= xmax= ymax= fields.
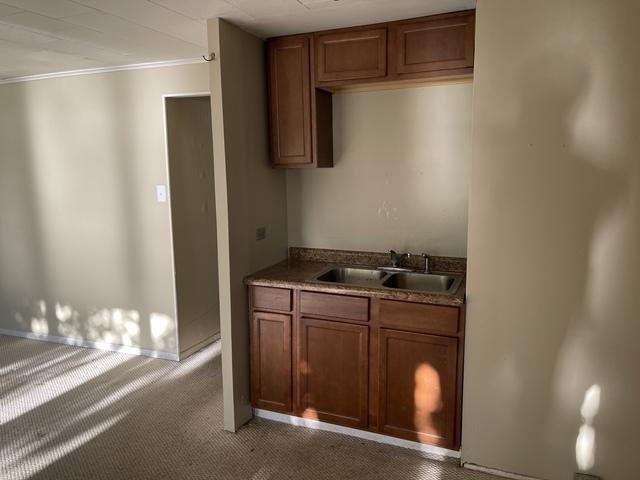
xmin=298 ymin=318 xmax=369 ymax=428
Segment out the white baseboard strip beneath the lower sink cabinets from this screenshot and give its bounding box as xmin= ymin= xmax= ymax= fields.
xmin=253 ymin=408 xmax=460 ymax=460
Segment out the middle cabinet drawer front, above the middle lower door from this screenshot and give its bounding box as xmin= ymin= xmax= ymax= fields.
xmin=300 ymin=292 xmax=369 ymax=322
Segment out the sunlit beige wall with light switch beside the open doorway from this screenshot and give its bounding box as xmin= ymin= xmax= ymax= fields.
xmin=0 ymin=65 xmax=208 ymax=353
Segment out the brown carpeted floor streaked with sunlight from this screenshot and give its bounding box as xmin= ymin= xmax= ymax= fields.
xmin=0 ymin=336 xmax=495 ymax=480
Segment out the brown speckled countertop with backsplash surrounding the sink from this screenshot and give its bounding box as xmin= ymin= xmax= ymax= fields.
xmin=245 ymin=248 xmax=466 ymax=306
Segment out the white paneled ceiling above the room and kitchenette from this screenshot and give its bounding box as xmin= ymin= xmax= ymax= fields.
xmin=0 ymin=0 xmax=475 ymax=80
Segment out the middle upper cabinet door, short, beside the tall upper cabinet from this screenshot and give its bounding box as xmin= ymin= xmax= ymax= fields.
xmin=314 ymin=28 xmax=387 ymax=83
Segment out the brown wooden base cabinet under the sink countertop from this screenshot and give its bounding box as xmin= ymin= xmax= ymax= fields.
xmin=250 ymin=286 xmax=464 ymax=449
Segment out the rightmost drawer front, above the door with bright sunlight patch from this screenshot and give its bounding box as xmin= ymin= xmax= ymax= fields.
xmin=380 ymin=300 xmax=460 ymax=335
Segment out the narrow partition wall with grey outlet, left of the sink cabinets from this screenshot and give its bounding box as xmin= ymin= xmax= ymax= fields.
xmin=207 ymin=19 xmax=287 ymax=431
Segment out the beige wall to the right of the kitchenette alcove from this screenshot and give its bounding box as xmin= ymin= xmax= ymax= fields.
xmin=463 ymin=0 xmax=640 ymax=479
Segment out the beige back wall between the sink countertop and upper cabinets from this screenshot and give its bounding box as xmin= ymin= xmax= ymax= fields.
xmin=287 ymin=83 xmax=472 ymax=256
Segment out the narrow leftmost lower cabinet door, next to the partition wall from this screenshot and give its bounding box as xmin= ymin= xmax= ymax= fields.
xmin=251 ymin=312 xmax=293 ymax=412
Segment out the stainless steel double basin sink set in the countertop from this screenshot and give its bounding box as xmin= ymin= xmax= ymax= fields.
xmin=314 ymin=267 xmax=462 ymax=295
